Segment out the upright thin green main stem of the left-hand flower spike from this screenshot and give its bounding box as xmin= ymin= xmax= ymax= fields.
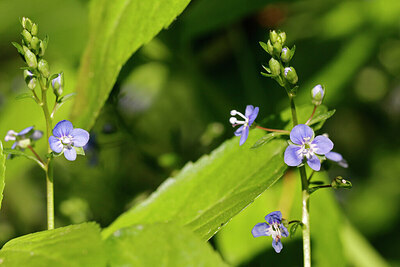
xmin=39 ymin=78 xmax=54 ymax=230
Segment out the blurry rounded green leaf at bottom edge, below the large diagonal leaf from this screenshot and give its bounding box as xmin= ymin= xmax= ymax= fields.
xmin=106 ymin=223 xmax=227 ymax=267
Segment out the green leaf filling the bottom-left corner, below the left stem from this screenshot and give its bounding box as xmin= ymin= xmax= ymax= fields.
xmin=0 ymin=223 xmax=107 ymax=267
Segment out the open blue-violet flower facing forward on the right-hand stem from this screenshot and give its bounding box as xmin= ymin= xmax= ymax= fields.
xmin=284 ymin=124 xmax=333 ymax=171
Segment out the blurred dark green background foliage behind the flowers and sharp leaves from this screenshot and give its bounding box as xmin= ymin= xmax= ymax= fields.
xmin=0 ymin=0 xmax=400 ymax=266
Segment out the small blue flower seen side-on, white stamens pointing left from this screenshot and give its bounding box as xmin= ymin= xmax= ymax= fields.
xmin=229 ymin=105 xmax=258 ymax=145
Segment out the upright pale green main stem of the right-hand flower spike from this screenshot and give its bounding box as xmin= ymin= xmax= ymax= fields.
xmin=289 ymin=94 xmax=311 ymax=267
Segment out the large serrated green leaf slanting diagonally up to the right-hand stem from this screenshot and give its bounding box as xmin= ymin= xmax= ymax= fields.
xmin=103 ymin=106 xmax=324 ymax=240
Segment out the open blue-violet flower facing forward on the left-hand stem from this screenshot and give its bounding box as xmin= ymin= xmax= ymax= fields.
xmin=49 ymin=120 xmax=89 ymax=161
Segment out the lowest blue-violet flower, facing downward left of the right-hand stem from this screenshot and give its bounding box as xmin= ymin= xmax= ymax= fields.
xmin=251 ymin=211 xmax=289 ymax=253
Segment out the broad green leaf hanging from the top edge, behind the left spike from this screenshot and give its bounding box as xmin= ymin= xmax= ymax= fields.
xmin=71 ymin=0 xmax=190 ymax=129
